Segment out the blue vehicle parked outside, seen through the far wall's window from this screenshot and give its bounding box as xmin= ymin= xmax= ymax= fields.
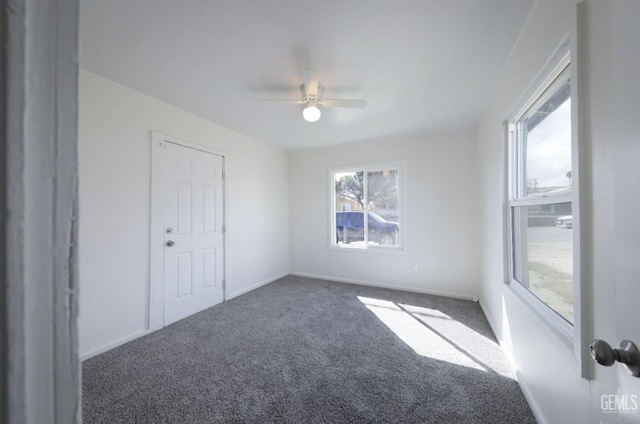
xmin=336 ymin=211 xmax=399 ymax=245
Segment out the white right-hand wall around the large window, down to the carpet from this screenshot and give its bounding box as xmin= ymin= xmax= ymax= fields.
xmin=478 ymin=0 xmax=588 ymax=423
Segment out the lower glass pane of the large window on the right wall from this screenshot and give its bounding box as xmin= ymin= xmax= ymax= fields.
xmin=512 ymin=202 xmax=573 ymax=323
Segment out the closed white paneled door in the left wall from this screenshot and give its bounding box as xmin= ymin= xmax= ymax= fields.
xmin=161 ymin=141 xmax=224 ymax=325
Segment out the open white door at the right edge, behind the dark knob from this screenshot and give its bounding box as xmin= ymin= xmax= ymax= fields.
xmin=610 ymin=0 xmax=640 ymax=423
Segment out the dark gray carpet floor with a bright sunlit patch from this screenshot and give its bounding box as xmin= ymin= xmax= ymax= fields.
xmin=82 ymin=276 xmax=535 ymax=424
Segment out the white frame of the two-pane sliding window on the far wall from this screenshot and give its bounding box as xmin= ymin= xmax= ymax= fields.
xmin=328 ymin=160 xmax=405 ymax=253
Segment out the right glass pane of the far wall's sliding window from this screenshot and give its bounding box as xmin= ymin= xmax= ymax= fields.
xmin=367 ymin=169 xmax=400 ymax=246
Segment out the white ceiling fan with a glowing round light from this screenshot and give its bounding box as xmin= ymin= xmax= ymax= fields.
xmin=258 ymin=69 xmax=367 ymax=122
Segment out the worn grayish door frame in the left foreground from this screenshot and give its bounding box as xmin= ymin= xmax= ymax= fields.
xmin=0 ymin=0 xmax=82 ymax=423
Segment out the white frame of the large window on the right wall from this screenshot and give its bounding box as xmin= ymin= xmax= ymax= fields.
xmin=503 ymin=35 xmax=586 ymax=348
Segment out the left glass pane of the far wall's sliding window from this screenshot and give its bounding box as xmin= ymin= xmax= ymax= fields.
xmin=334 ymin=171 xmax=365 ymax=245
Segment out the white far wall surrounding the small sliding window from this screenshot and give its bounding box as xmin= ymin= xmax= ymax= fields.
xmin=289 ymin=128 xmax=480 ymax=297
